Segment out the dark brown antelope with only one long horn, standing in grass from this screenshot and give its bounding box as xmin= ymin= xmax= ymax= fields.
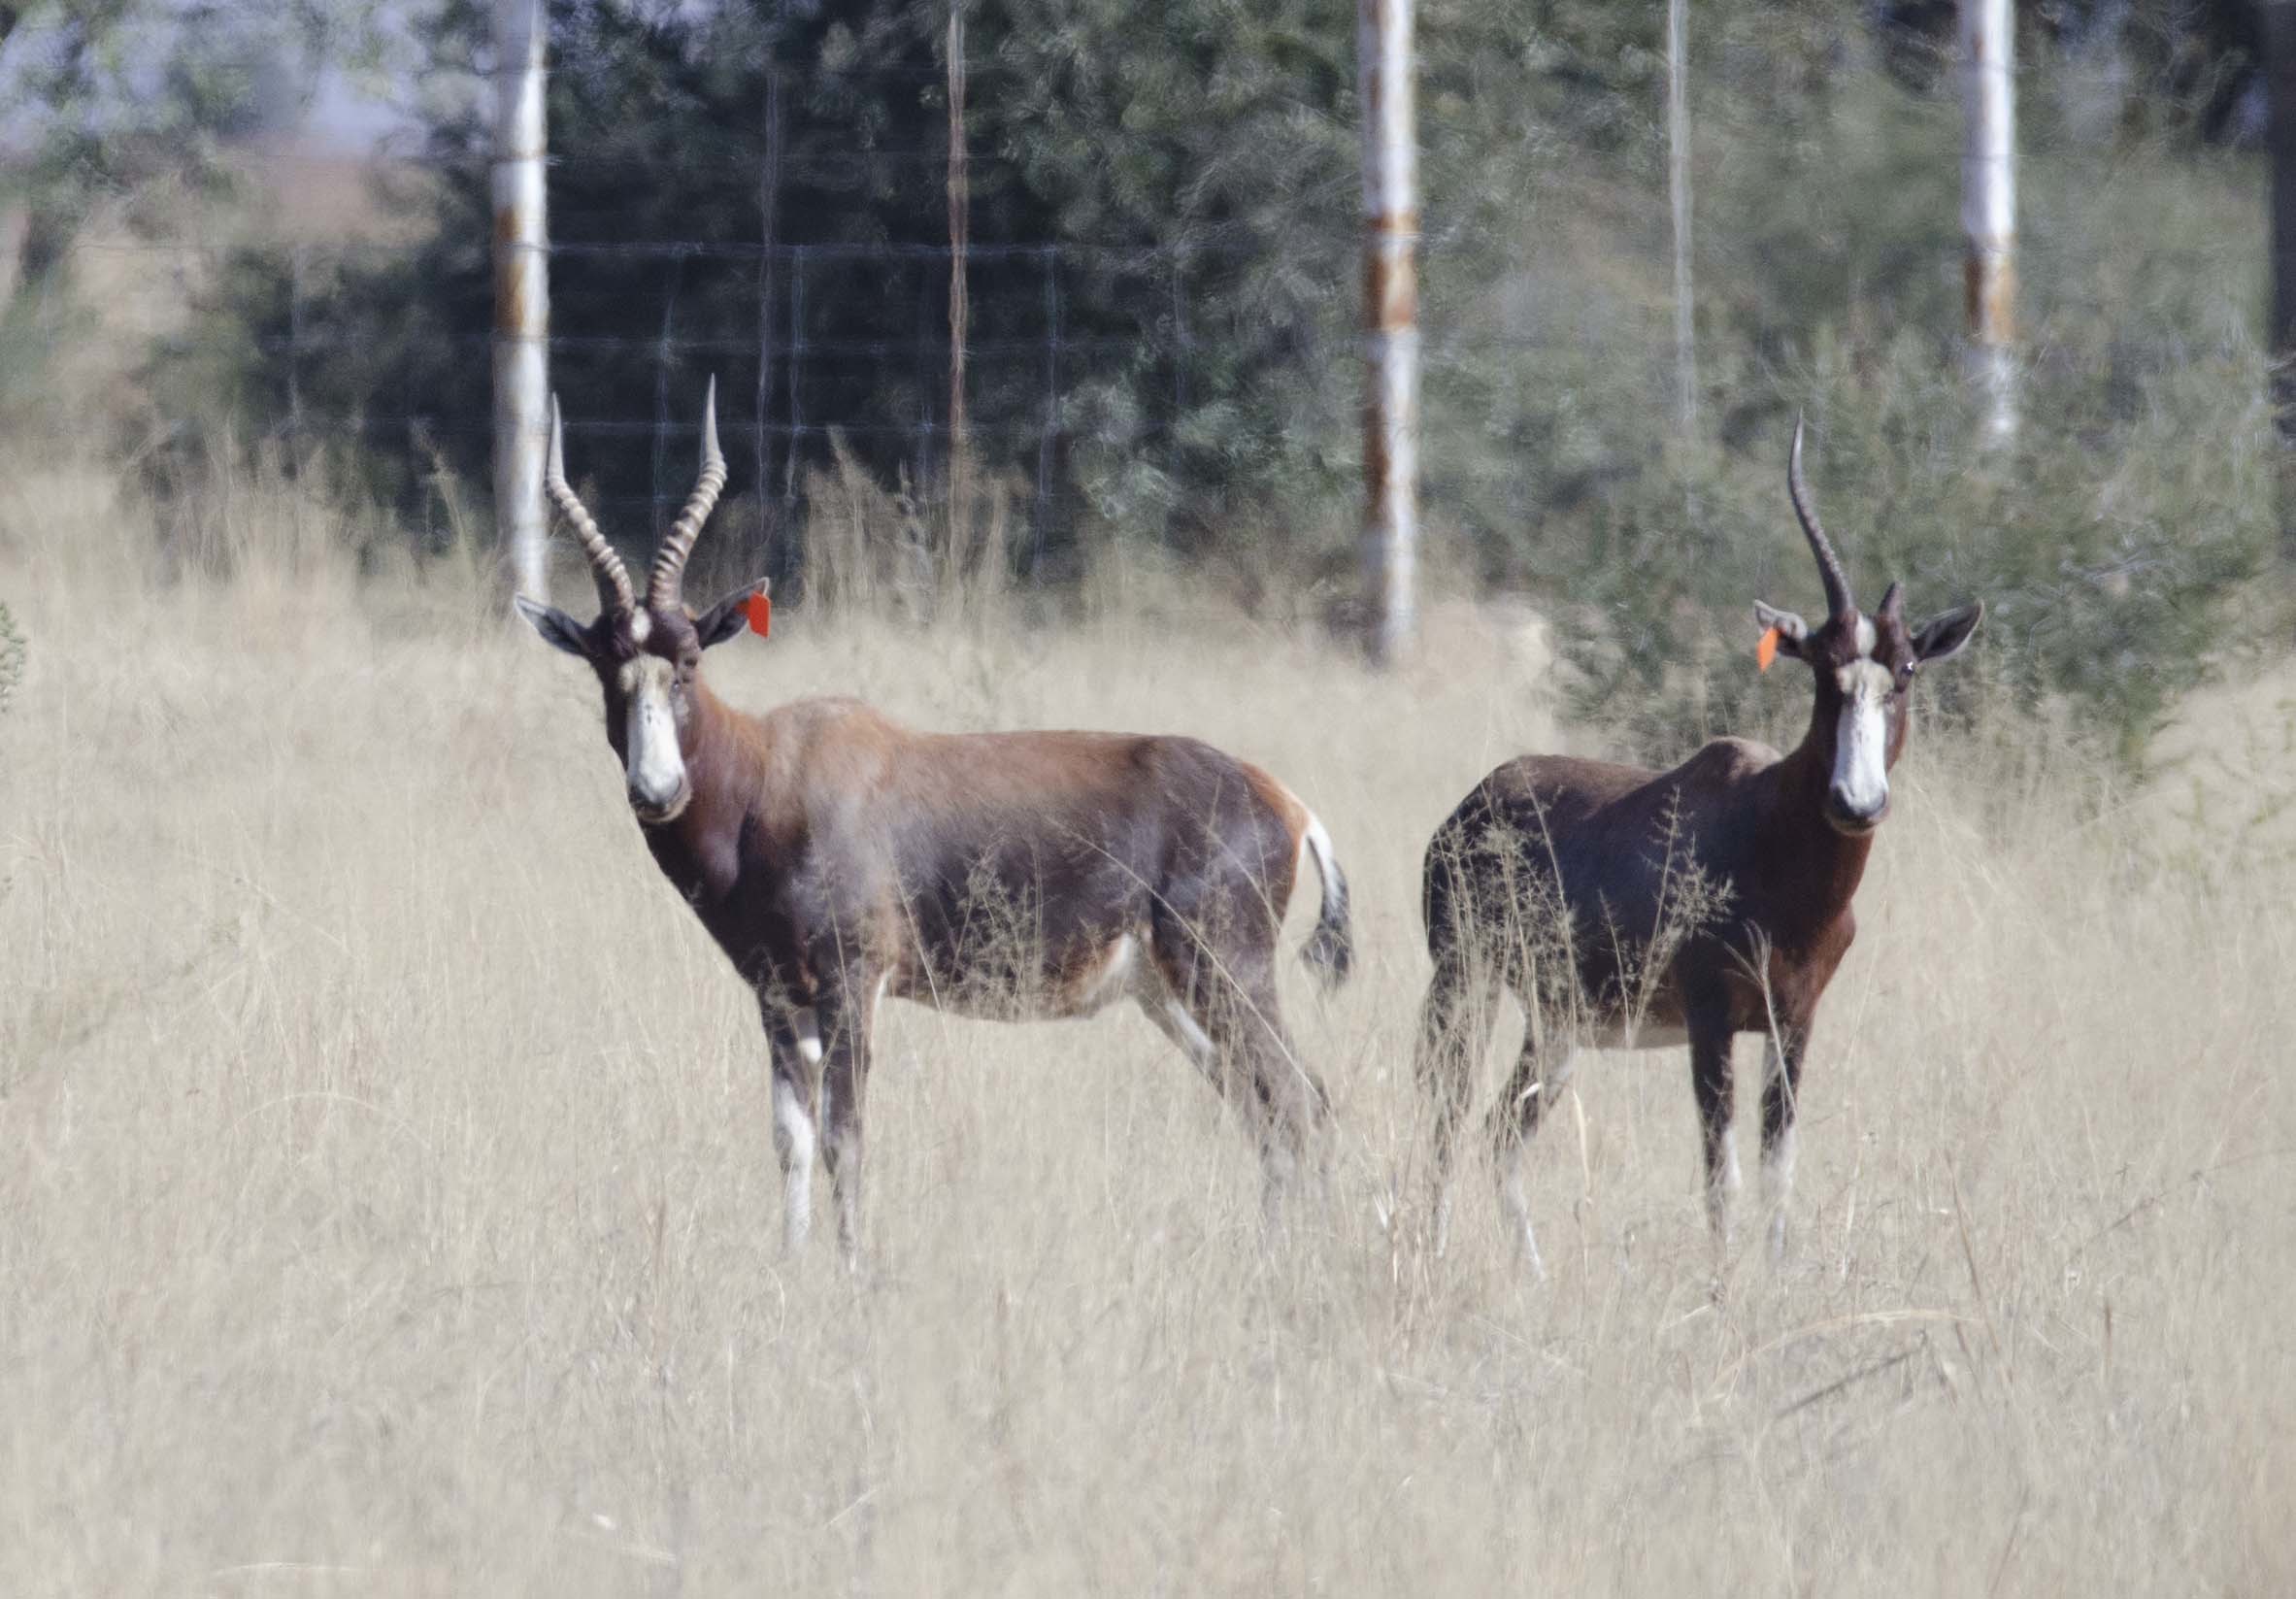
xmin=1416 ymin=418 xmax=1983 ymax=1273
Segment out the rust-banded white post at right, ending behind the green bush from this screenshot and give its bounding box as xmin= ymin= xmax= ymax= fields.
xmin=1961 ymin=0 xmax=2015 ymax=444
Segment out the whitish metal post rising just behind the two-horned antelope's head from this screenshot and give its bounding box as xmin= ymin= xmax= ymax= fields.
xmin=493 ymin=0 xmax=551 ymax=600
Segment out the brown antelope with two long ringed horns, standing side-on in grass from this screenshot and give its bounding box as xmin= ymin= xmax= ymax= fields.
xmin=518 ymin=383 xmax=1350 ymax=1259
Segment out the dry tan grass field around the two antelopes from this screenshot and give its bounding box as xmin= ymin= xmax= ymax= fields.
xmin=0 ymin=454 xmax=2296 ymax=1594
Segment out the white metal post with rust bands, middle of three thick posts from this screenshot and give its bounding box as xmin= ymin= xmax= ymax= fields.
xmin=1354 ymin=0 xmax=1419 ymax=662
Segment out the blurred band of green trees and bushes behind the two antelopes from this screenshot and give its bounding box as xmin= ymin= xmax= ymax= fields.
xmin=0 ymin=0 xmax=2284 ymax=758
